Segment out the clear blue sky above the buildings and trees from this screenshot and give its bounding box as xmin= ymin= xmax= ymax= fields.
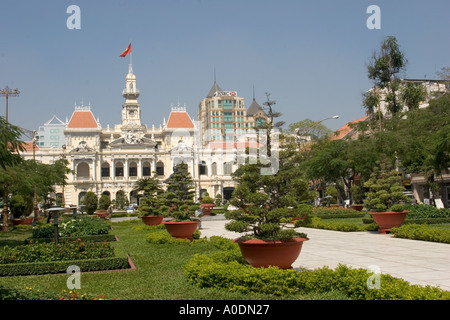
xmin=0 ymin=0 xmax=450 ymax=130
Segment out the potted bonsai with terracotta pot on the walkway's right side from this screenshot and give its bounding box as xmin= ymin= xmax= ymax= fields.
xmin=364 ymin=161 xmax=409 ymax=233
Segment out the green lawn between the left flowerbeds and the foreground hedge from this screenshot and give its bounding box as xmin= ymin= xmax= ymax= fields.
xmin=0 ymin=220 xmax=347 ymax=300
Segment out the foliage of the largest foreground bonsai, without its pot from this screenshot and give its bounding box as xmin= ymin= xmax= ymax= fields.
xmin=225 ymin=142 xmax=314 ymax=240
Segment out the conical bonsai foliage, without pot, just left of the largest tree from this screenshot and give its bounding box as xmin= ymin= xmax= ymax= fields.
xmin=159 ymin=162 xmax=199 ymax=222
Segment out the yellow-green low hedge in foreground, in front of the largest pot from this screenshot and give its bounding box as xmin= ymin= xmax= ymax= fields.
xmin=184 ymin=239 xmax=450 ymax=300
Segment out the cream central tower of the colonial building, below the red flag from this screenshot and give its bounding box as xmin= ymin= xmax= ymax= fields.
xmin=122 ymin=64 xmax=141 ymax=129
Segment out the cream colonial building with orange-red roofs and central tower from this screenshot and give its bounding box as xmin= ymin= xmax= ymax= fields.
xmin=24 ymin=64 xmax=262 ymax=205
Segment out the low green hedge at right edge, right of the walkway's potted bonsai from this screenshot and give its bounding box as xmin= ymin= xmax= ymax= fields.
xmin=391 ymin=224 xmax=450 ymax=243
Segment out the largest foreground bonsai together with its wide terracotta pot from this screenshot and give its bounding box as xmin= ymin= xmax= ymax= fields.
xmin=225 ymin=147 xmax=314 ymax=269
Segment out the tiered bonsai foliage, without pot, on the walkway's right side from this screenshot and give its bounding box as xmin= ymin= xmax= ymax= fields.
xmin=364 ymin=160 xmax=407 ymax=212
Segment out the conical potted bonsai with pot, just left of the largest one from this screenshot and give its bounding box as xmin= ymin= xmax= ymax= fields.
xmin=160 ymin=162 xmax=199 ymax=241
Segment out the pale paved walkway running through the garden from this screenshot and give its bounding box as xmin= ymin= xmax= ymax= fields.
xmin=200 ymin=215 xmax=450 ymax=291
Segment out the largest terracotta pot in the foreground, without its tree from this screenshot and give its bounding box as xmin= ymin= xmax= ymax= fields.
xmin=234 ymin=238 xmax=308 ymax=269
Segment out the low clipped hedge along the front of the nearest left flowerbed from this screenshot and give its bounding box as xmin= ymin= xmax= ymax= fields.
xmin=0 ymin=257 xmax=130 ymax=276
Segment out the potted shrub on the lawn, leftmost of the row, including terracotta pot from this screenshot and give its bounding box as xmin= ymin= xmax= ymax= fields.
xmin=134 ymin=174 xmax=164 ymax=225
